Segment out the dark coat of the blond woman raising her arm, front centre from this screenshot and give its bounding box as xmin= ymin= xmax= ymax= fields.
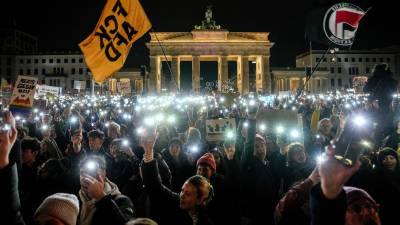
xmin=142 ymin=160 xmax=213 ymax=225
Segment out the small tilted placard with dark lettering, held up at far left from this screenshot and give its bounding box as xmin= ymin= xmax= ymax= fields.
xmin=10 ymin=76 xmax=37 ymax=114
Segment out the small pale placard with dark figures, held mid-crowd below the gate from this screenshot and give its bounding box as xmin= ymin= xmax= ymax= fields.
xmin=206 ymin=118 xmax=236 ymax=141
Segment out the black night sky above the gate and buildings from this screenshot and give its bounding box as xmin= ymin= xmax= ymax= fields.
xmin=1 ymin=0 xmax=400 ymax=67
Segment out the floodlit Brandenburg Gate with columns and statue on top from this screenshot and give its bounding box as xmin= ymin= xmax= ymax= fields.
xmin=147 ymin=8 xmax=273 ymax=94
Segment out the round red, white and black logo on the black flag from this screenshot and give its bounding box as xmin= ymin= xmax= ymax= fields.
xmin=323 ymin=3 xmax=365 ymax=46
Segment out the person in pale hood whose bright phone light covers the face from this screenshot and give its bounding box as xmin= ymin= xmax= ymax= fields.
xmin=79 ymin=156 xmax=134 ymax=225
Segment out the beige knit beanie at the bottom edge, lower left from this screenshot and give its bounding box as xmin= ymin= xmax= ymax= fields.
xmin=34 ymin=193 xmax=79 ymax=225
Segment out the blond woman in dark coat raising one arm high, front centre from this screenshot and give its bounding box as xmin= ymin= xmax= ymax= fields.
xmin=141 ymin=126 xmax=214 ymax=225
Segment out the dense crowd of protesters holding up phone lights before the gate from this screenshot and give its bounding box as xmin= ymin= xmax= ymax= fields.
xmin=0 ymin=63 xmax=400 ymax=225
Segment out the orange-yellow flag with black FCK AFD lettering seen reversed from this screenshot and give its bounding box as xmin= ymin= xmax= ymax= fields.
xmin=79 ymin=0 xmax=151 ymax=83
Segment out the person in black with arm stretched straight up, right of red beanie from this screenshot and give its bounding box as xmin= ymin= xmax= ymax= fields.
xmin=240 ymin=100 xmax=284 ymax=225
